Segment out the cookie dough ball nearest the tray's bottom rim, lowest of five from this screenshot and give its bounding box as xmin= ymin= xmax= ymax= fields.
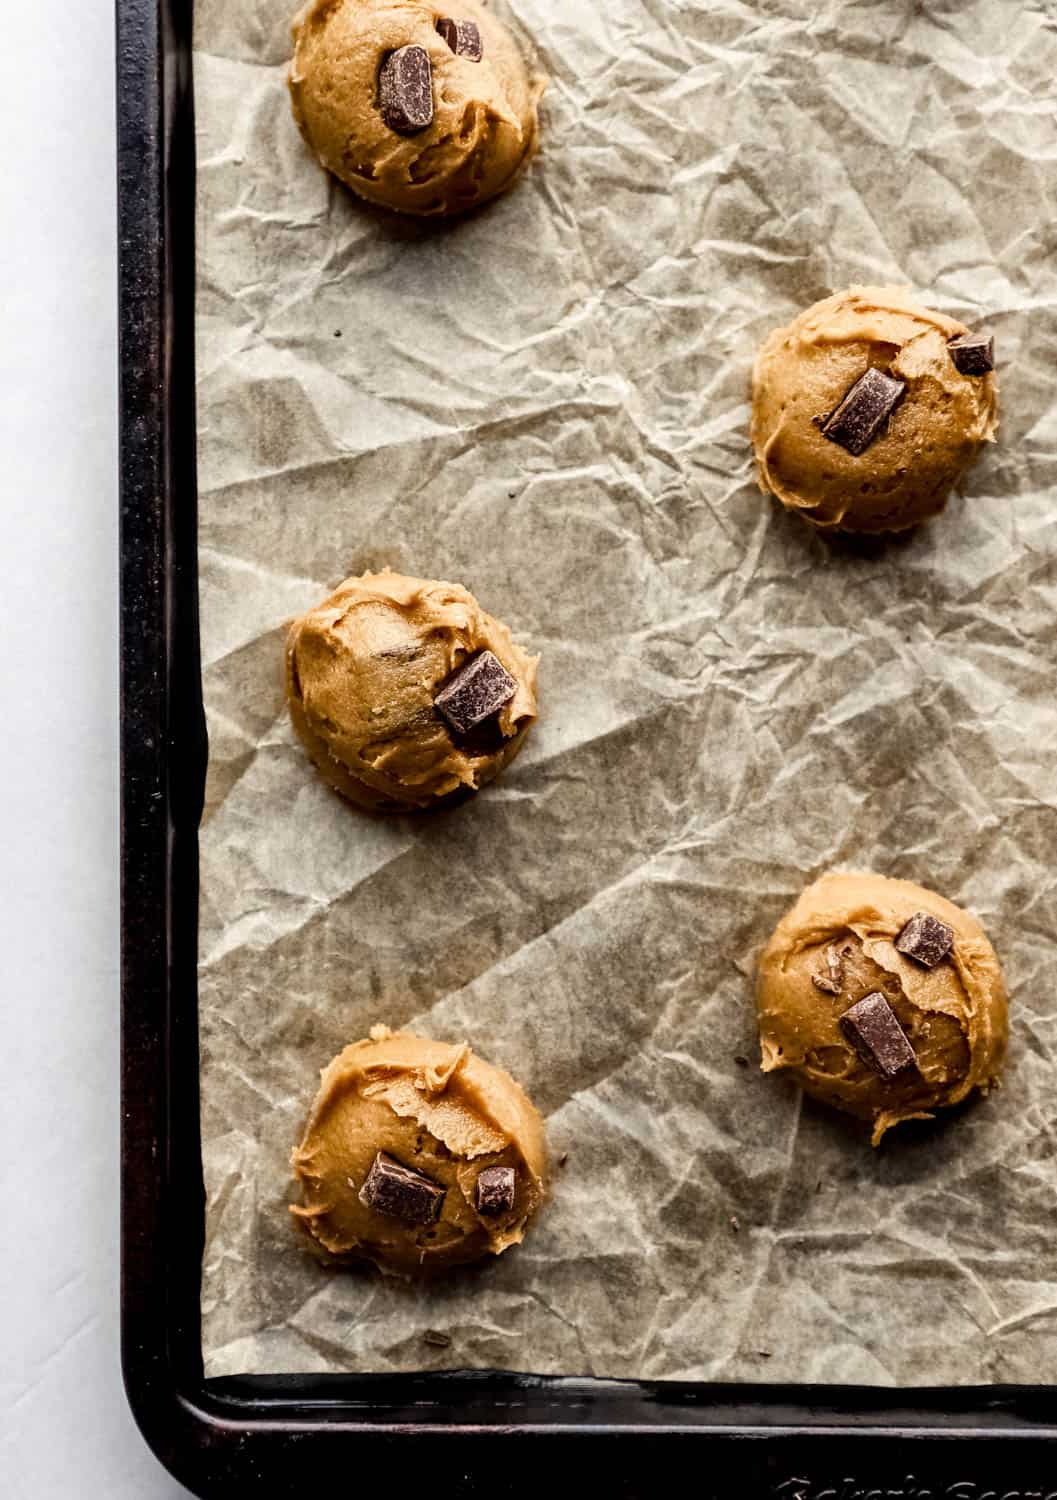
xmin=291 ymin=1026 xmax=546 ymax=1277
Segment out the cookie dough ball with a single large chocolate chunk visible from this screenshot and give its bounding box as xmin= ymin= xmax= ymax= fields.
xmin=286 ymin=569 xmax=538 ymax=813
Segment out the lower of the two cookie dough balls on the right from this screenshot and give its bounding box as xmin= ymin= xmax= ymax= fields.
xmin=756 ymin=875 xmax=1008 ymax=1146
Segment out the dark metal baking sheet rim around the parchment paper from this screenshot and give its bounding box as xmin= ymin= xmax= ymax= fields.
xmin=118 ymin=0 xmax=1057 ymax=1500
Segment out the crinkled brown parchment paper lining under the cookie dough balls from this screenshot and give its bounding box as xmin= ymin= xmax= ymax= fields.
xmin=195 ymin=0 xmax=1057 ymax=1385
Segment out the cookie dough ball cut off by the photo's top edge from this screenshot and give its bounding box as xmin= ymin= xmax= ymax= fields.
xmin=289 ymin=0 xmax=544 ymax=215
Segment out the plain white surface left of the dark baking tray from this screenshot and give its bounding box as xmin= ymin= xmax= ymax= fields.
xmin=0 ymin=0 xmax=187 ymax=1500
